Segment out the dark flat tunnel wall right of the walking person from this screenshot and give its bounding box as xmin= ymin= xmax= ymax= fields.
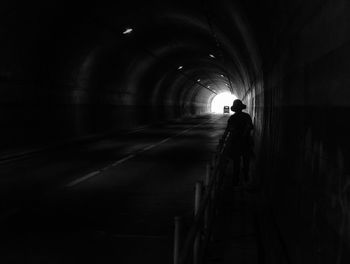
xmin=259 ymin=0 xmax=350 ymax=264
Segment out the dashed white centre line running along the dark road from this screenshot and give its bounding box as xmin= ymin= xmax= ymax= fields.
xmin=66 ymin=119 xmax=207 ymax=187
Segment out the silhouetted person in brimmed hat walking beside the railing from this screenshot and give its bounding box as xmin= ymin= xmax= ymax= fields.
xmin=222 ymin=99 xmax=253 ymax=186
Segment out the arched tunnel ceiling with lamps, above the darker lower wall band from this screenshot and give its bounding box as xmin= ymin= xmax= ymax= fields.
xmin=1 ymin=0 xmax=260 ymax=114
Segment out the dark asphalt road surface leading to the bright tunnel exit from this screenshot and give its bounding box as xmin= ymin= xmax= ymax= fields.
xmin=0 ymin=115 xmax=228 ymax=263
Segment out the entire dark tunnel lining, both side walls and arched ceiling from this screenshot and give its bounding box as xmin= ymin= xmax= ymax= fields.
xmin=0 ymin=0 xmax=350 ymax=263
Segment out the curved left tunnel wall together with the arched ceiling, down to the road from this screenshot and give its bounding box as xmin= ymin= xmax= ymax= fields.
xmin=0 ymin=1 xmax=256 ymax=151
